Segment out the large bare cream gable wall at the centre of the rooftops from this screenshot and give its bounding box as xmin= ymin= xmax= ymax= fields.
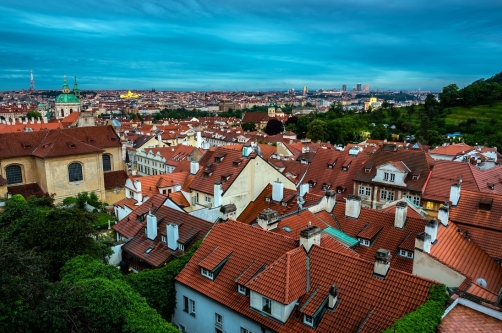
xmin=222 ymin=157 xmax=296 ymax=216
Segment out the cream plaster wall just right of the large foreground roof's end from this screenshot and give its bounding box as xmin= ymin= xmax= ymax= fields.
xmin=413 ymin=249 xmax=465 ymax=287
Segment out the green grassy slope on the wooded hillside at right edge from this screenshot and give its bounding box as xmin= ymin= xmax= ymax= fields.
xmin=445 ymin=102 xmax=502 ymax=125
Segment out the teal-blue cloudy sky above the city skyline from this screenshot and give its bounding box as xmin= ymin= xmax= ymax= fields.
xmin=0 ymin=0 xmax=502 ymax=90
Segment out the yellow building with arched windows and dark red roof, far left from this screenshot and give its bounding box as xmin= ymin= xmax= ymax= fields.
xmin=0 ymin=126 xmax=127 ymax=202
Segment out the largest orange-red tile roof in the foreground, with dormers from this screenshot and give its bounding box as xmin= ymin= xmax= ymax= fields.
xmin=176 ymin=220 xmax=433 ymax=333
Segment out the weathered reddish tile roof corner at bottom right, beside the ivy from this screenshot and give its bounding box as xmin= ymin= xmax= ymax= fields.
xmin=437 ymin=304 xmax=502 ymax=333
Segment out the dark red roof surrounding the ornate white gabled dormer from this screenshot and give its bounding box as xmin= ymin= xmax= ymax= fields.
xmin=354 ymin=149 xmax=434 ymax=192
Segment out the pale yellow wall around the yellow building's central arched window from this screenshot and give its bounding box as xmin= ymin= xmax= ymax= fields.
xmin=45 ymin=153 xmax=106 ymax=202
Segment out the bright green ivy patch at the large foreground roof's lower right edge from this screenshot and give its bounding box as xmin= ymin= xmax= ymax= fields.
xmin=382 ymin=285 xmax=450 ymax=333
